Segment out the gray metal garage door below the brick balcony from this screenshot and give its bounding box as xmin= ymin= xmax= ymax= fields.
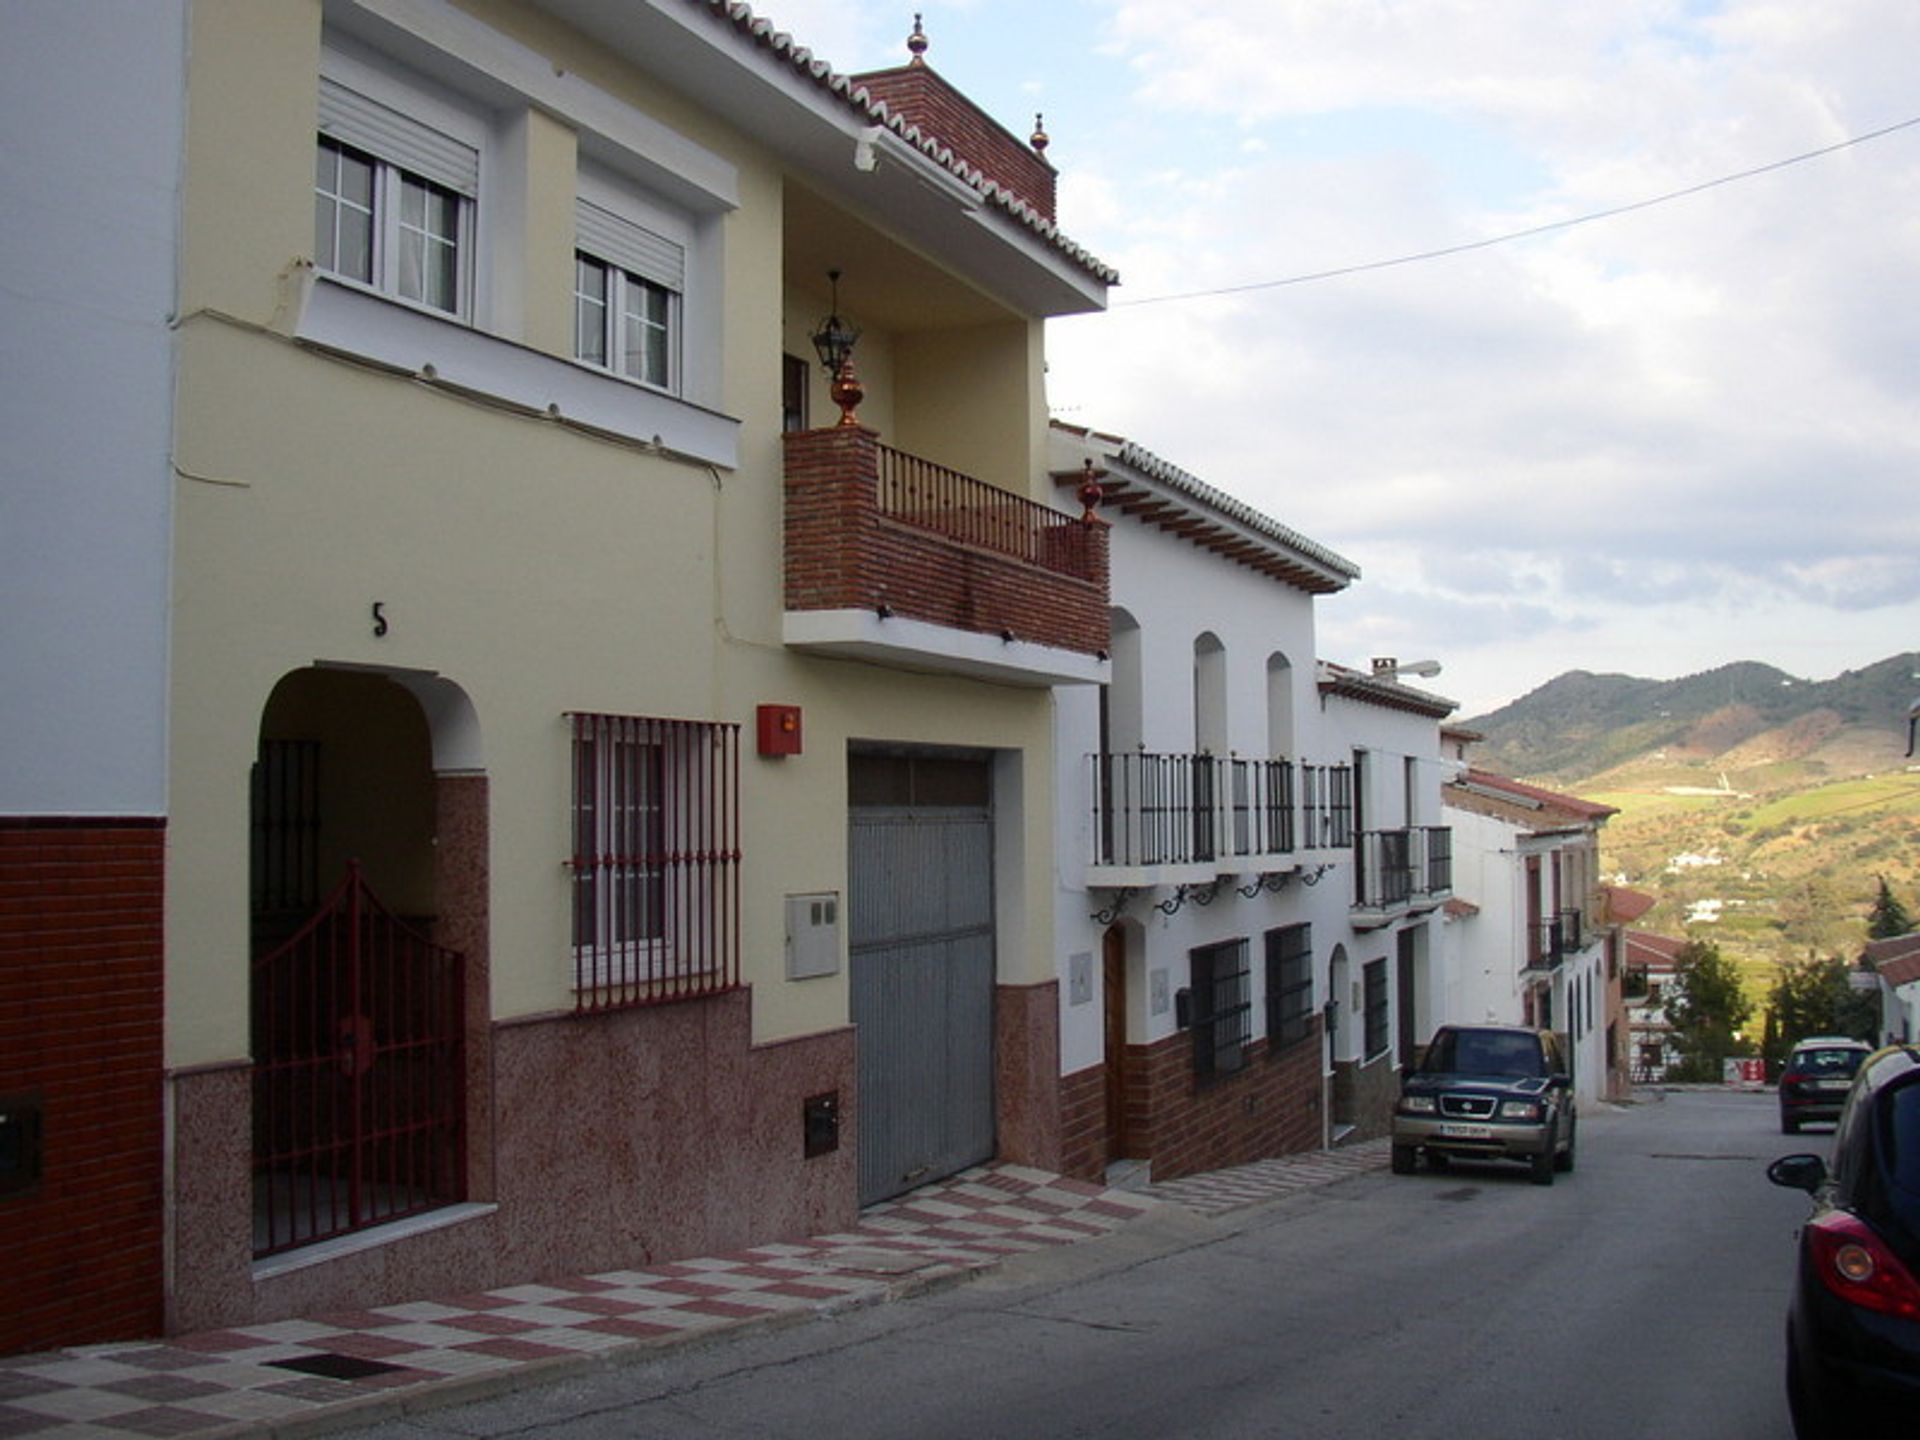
xmin=847 ymin=766 xmax=995 ymax=1206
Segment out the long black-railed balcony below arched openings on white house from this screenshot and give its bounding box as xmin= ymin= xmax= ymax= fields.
xmin=1087 ymin=753 xmax=1296 ymax=889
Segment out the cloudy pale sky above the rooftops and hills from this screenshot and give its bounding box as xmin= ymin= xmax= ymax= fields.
xmin=755 ymin=0 xmax=1920 ymax=716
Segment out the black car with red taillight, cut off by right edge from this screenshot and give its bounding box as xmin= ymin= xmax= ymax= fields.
xmin=1766 ymin=1044 xmax=1920 ymax=1440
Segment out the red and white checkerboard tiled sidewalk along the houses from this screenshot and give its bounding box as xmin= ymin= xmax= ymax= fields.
xmin=0 ymin=1142 xmax=1386 ymax=1440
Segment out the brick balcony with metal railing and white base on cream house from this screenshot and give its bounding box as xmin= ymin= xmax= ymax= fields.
xmin=783 ymin=424 xmax=1108 ymax=687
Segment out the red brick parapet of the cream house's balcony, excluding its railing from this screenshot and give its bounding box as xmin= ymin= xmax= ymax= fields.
xmin=785 ymin=426 xmax=1110 ymax=655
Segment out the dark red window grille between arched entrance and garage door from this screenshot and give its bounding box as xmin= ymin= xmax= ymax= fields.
xmin=570 ymin=714 xmax=739 ymax=1010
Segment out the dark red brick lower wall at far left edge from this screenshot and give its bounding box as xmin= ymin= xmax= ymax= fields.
xmin=0 ymin=818 xmax=165 ymax=1354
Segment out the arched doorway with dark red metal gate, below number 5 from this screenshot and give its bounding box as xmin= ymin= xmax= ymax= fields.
xmin=250 ymin=666 xmax=490 ymax=1256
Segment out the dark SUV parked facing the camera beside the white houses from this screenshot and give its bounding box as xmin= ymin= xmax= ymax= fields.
xmin=1392 ymin=1025 xmax=1576 ymax=1185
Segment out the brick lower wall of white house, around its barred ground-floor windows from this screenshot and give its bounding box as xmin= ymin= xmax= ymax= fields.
xmin=1060 ymin=1029 xmax=1323 ymax=1181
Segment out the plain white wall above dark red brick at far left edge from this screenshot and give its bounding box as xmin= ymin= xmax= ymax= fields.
xmin=0 ymin=0 xmax=186 ymax=816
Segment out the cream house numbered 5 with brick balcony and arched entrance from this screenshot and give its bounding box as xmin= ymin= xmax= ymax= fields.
xmin=11 ymin=0 xmax=1114 ymax=1351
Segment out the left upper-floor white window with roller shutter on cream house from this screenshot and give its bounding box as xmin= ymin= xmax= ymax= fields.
xmin=315 ymin=36 xmax=488 ymax=324
